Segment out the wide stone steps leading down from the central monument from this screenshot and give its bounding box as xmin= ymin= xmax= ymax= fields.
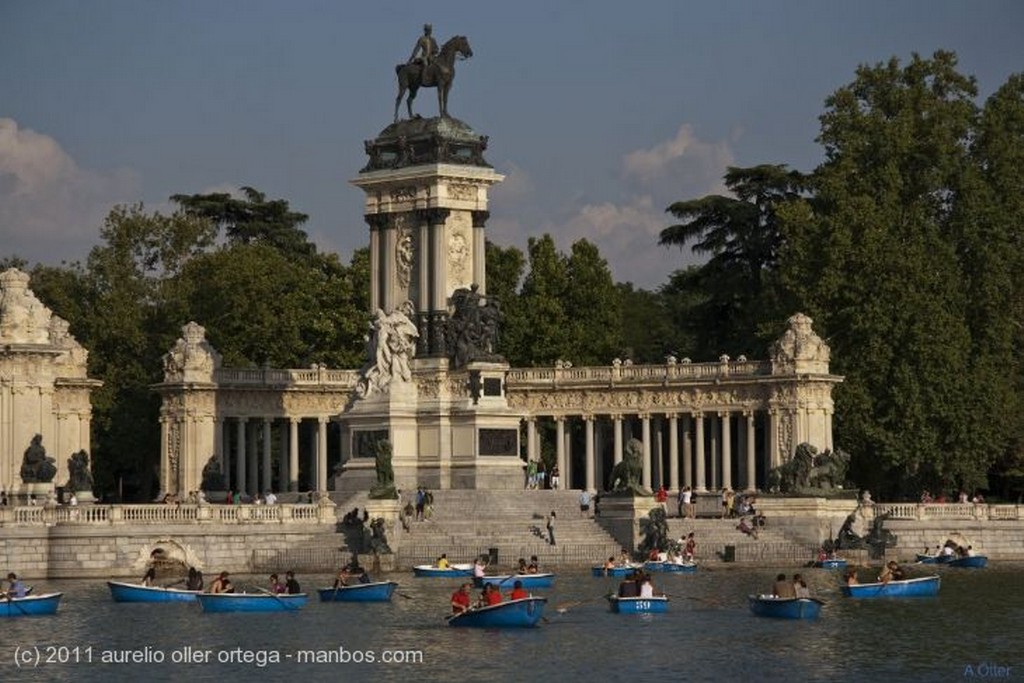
xmin=336 ymin=489 xmax=621 ymax=570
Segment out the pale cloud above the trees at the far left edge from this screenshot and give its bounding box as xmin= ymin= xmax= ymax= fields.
xmin=0 ymin=118 xmax=139 ymax=264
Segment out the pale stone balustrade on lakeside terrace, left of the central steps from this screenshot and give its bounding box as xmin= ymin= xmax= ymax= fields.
xmin=0 ymin=504 xmax=337 ymax=527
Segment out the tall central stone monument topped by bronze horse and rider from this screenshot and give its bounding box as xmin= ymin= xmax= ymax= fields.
xmin=336 ymin=37 xmax=522 ymax=490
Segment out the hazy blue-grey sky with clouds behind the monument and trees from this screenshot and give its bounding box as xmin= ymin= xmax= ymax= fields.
xmin=0 ymin=0 xmax=1024 ymax=289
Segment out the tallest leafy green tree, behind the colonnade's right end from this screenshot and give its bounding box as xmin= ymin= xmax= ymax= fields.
xmin=781 ymin=52 xmax=1007 ymax=495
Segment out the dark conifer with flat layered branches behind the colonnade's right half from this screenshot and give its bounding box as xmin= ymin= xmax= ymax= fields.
xmin=658 ymin=165 xmax=806 ymax=358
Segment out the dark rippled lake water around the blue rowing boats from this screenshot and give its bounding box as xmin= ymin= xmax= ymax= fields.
xmin=0 ymin=565 xmax=1024 ymax=683
